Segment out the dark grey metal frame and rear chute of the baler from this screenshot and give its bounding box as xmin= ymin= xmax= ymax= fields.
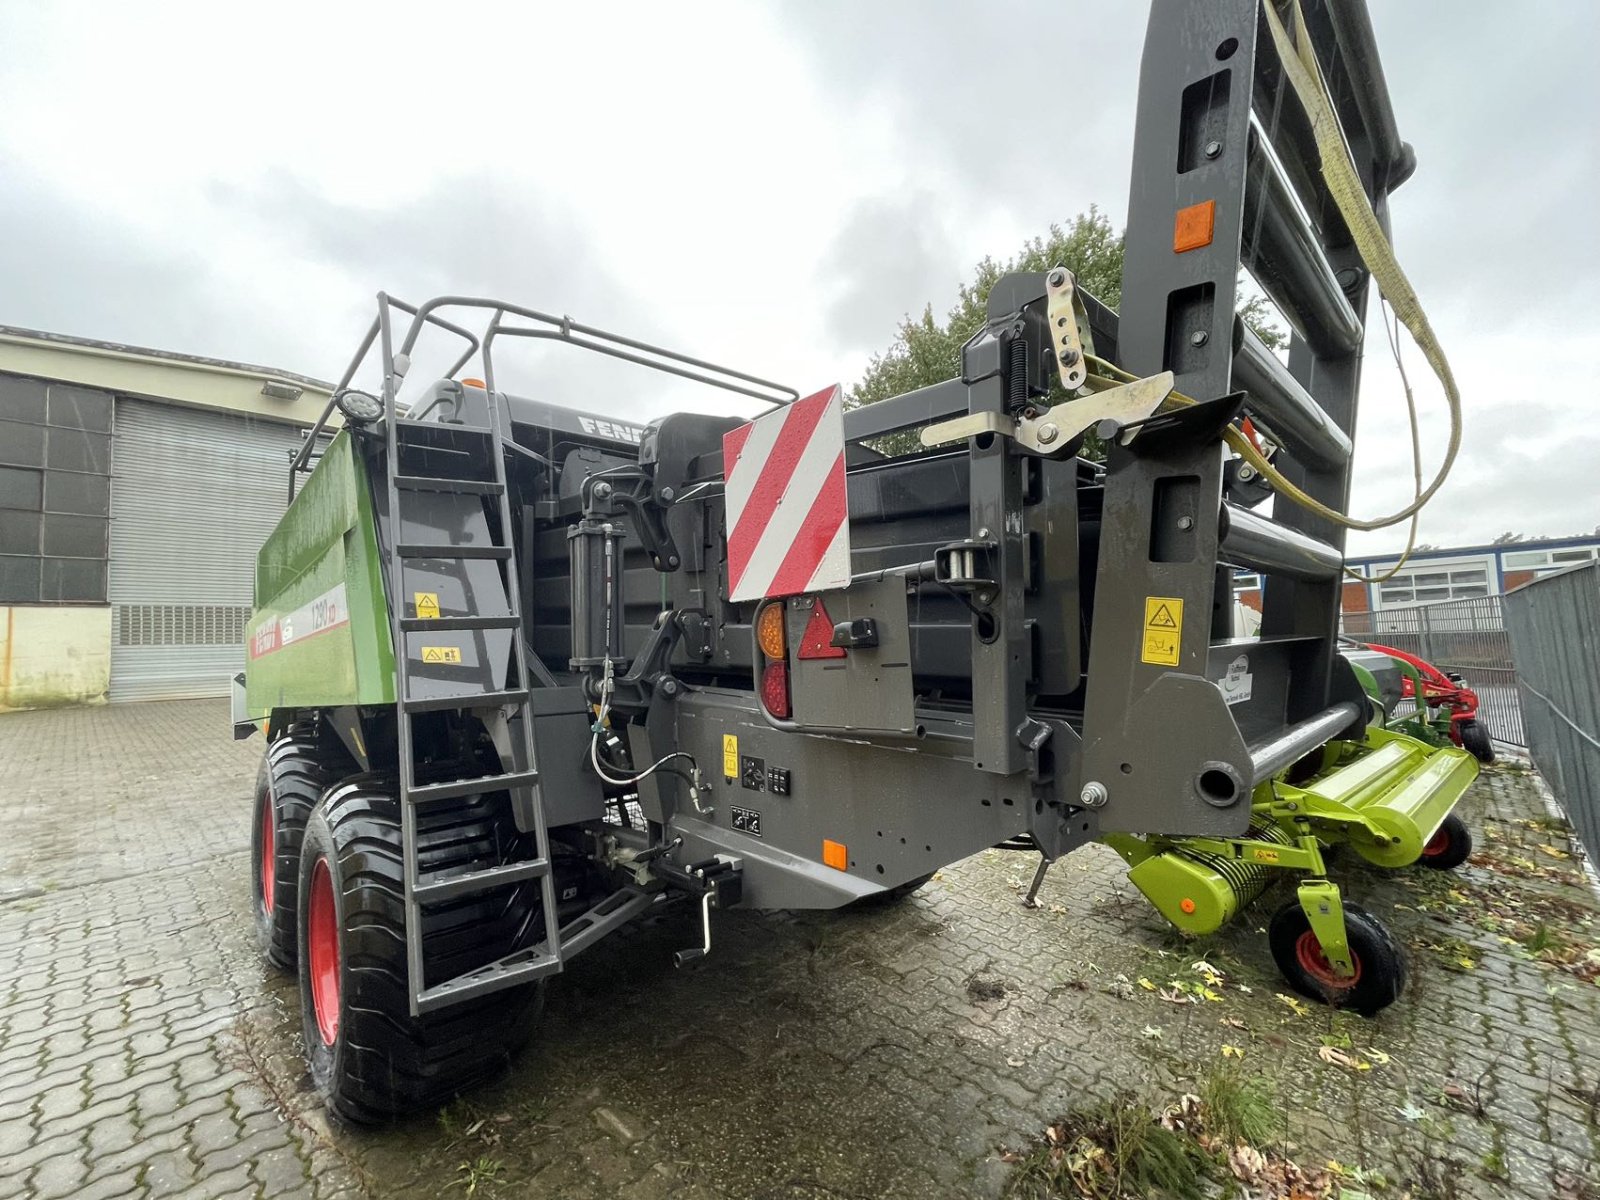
xmin=291 ymin=0 xmax=1413 ymax=1003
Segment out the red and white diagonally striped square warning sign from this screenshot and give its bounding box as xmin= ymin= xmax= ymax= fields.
xmin=722 ymin=384 xmax=850 ymax=600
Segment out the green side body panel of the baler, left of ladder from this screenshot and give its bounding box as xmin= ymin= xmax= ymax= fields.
xmin=245 ymin=432 xmax=395 ymax=720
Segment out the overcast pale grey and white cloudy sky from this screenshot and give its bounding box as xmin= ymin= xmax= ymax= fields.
xmin=0 ymin=0 xmax=1600 ymax=552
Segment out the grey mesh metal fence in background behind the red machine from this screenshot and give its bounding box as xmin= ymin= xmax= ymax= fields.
xmin=1344 ymin=595 xmax=1528 ymax=746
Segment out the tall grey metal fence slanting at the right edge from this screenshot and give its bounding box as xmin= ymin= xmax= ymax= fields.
xmin=1506 ymin=563 xmax=1600 ymax=859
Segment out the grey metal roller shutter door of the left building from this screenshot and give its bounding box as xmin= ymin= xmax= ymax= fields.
xmin=110 ymin=397 xmax=301 ymax=701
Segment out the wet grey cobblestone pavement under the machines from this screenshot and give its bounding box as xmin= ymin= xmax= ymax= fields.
xmin=0 ymin=702 xmax=1600 ymax=1200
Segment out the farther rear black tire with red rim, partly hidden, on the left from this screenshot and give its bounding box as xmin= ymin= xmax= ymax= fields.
xmin=251 ymin=723 xmax=331 ymax=973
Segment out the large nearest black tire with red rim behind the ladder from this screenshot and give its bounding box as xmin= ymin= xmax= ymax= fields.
xmin=299 ymin=778 xmax=544 ymax=1125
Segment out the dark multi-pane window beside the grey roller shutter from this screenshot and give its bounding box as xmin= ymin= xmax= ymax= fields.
xmin=0 ymin=374 xmax=112 ymax=605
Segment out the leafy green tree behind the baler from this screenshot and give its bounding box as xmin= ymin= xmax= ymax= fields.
xmin=850 ymin=205 xmax=1285 ymax=458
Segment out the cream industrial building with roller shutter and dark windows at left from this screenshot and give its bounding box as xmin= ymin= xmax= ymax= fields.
xmin=0 ymin=326 xmax=330 ymax=710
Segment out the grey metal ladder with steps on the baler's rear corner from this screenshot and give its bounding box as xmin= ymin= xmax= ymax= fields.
xmin=379 ymin=361 xmax=562 ymax=1016
